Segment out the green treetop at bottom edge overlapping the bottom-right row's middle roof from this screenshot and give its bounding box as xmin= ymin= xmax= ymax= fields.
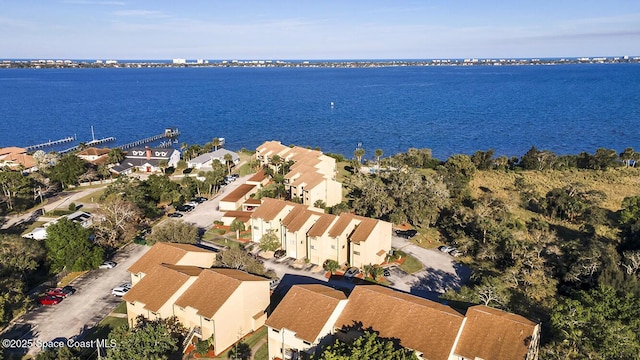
xmin=314 ymin=331 xmax=418 ymax=360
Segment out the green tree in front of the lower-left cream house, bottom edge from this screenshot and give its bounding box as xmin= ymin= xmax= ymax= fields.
xmin=107 ymin=317 xmax=185 ymax=360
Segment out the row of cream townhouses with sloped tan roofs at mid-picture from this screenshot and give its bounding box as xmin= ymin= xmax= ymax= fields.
xmin=251 ymin=198 xmax=392 ymax=267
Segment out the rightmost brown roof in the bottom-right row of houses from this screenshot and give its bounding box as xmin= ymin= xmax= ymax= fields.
xmin=454 ymin=305 xmax=537 ymax=360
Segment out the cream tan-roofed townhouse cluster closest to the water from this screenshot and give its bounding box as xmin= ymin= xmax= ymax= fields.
xmin=256 ymin=141 xmax=342 ymax=206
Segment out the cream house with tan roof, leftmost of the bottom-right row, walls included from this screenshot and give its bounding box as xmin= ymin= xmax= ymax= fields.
xmin=266 ymin=284 xmax=347 ymax=359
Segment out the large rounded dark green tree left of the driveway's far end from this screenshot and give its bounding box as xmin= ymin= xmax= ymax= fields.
xmin=45 ymin=218 xmax=103 ymax=272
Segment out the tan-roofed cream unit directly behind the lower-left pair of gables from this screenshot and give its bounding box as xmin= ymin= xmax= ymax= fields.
xmin=127 ymin=242 xmax=216 ymax=285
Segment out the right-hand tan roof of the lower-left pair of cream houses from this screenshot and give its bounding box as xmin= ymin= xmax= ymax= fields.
xmin=175 ymin=269 xmax=269 ymax=318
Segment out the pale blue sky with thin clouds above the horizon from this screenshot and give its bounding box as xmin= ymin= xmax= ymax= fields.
xmin=0 ymin=0 xmax=640 ymax=60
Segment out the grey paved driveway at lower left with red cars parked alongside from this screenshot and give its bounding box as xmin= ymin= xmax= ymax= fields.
xmin=2 ymin=244 xmax=150 ymax=354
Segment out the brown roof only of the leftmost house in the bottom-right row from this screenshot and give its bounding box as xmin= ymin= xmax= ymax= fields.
xmin=266 ymin=284 xmax=346 ymax=342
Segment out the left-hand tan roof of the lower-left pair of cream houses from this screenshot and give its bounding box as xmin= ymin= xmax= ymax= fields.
xmin=122 ymin=264 xmax=202 ymax=312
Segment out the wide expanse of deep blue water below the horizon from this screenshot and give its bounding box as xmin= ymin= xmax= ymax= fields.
xmin=0 ymin=64 xmax=640 ymax=159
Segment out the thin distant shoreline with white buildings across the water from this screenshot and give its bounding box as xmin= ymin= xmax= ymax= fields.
xmin=0 ymin=56 xmax=640 ymax=69
